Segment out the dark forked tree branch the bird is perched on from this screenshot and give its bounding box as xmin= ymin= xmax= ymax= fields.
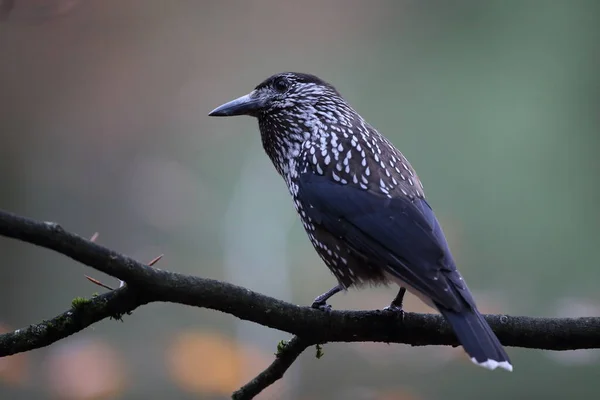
xmin=0 ymin=211 xmax=600 ymax=399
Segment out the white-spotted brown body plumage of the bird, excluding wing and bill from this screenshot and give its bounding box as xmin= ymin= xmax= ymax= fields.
xmin=247 ymin=74 xmax=424 ymax=286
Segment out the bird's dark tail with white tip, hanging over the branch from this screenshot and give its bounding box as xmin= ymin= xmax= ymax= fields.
xmin=440 ymin=307 xmax=512 ymax=371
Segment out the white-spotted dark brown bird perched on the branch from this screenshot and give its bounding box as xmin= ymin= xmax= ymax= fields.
xmin=209 ymin=72 xmax=513 ymax=371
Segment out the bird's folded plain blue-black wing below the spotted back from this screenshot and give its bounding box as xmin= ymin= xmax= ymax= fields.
xmin=298 ymin=168 xmax=474 ymax=311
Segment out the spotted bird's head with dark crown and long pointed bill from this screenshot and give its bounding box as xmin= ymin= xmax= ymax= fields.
xmin=208 ymin=72 xmax=341 ymax=120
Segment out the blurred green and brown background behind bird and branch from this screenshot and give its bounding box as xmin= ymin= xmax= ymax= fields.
xmin=0 ymin=0 xmax=600 ymax=400
